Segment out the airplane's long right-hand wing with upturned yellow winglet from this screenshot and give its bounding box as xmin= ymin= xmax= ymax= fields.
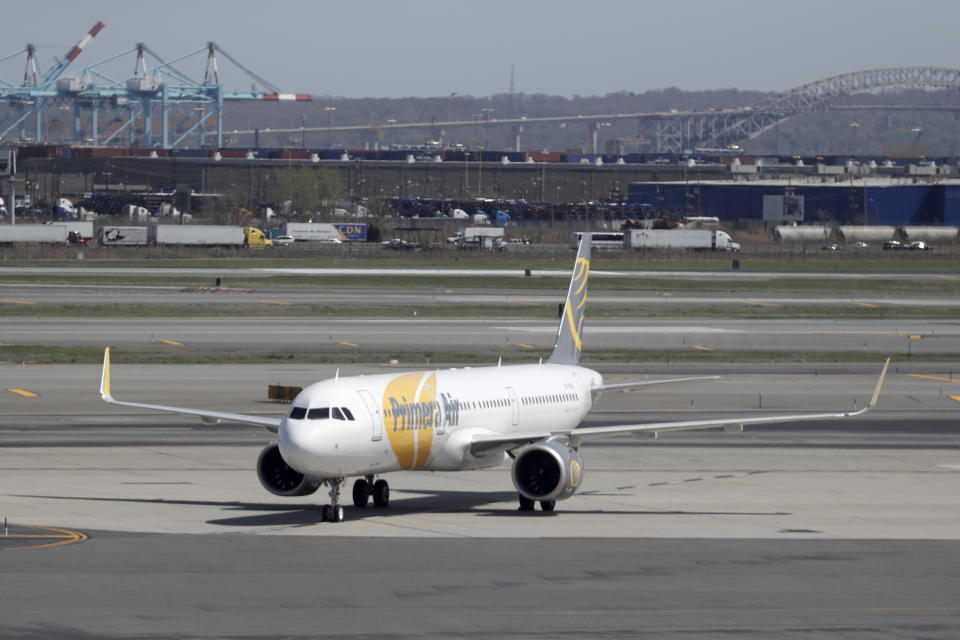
xmin=470 ymin=358 xmax=890 ymax=456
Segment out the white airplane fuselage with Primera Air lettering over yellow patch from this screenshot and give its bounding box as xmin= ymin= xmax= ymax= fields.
xmin=278 ymin=364 xmax=603 ymax=478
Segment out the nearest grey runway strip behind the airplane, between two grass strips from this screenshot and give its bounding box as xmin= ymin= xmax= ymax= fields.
xmin=0 ymin=315 xmax=960 ymax=355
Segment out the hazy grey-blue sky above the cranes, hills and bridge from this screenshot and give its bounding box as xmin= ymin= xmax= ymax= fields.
xmin=0 ymin=0 xmax=960 ymax=97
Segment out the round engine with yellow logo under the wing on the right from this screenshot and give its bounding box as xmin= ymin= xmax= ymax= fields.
xmin=511 ymin=442 xmax=583 ymax=501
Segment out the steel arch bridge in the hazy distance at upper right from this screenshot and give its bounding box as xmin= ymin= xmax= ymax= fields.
xmin=650 ymin=67 xmax=960 ymax=153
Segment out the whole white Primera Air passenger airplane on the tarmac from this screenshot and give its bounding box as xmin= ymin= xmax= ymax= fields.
xmin=100 ymin=238 xmax=890 ymax=522
